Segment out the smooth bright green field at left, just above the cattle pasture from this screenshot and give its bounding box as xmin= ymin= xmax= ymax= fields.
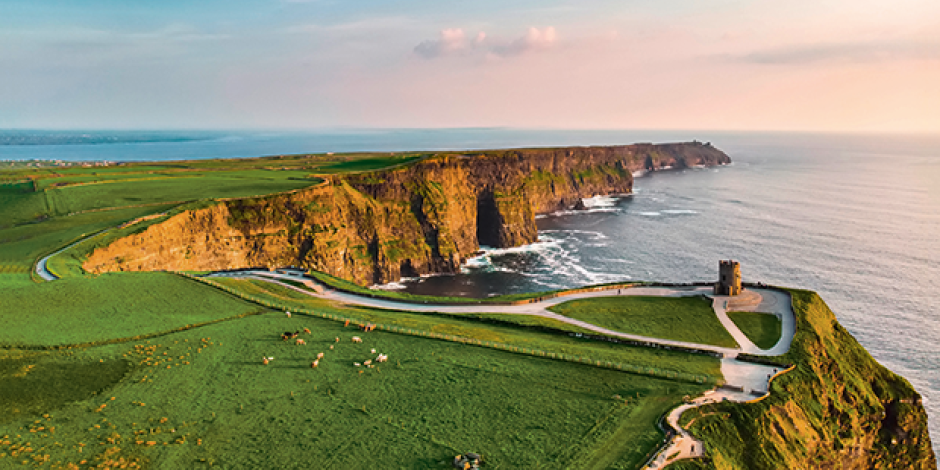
xmin=0 ymin=273 xmax=260 ymax=347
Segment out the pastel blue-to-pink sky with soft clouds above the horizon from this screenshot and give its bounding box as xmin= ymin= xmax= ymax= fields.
xmin=0 ymin=0 xmax=940 ymax=133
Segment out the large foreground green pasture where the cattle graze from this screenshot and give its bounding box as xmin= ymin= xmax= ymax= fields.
xmin=0 ymin=312 xmax=705 ymax=469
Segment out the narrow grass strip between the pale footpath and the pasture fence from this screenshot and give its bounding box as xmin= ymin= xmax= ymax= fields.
xmin=209 ymin=279 xmax=720 ymax=377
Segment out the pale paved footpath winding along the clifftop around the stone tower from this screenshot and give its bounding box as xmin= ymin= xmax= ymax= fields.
xmin=210 ymin=270 xmax=796 ymax=469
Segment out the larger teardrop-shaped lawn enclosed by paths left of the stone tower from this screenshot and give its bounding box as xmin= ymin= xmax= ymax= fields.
xmin=550 ymin=296 xmax=737 ymax=348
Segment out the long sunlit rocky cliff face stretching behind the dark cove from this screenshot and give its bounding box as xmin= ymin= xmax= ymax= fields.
xmin=83 ymin=143 xmax=730 ymax=284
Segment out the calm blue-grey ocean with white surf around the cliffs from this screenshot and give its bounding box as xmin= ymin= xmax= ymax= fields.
xmin=0 ymin=129 xmax=940 ymax=454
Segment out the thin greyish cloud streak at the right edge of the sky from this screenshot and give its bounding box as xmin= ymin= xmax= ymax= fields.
xmin=735 ymin=42 xmax=940 ymax=65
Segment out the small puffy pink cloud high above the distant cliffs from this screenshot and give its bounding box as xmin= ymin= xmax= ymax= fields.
xmin=414 ymin=26 xmax=558 ymax=59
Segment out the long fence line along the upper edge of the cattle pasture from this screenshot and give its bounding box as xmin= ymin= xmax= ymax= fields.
xmin=176 ymin=272 xmax=718 ymax=384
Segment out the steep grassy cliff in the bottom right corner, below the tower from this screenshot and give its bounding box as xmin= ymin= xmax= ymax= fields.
xmin=669 ymin=290 xmax=937 ymax=470
